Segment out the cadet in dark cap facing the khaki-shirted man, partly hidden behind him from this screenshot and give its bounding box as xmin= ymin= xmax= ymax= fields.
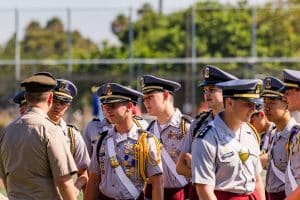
xmin=48 ymin=79 xmax=90 ymax=190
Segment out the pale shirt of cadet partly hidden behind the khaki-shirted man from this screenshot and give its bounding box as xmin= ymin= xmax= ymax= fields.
xmin=59 ymin=119 xmax=90 ymax=169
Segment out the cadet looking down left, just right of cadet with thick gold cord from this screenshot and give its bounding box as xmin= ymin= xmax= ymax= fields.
xmin=141 ymin=75 xmax=191 ymax=200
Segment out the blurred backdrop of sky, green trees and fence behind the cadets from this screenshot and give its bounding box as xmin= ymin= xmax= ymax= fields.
xmin=0 ymin=0 xmax=300 ymax=130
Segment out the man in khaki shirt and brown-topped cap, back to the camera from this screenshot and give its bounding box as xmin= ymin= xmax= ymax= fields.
xmin=0 ymin=72 xmax=78 ymax=200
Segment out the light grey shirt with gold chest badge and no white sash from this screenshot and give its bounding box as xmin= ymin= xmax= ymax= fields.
xmin=192 ymin=114 xmax=262 ymax=194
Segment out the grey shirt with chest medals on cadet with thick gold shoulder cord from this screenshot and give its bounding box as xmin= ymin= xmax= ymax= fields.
xmin=89 ymin=124 xmax=162 ymax=199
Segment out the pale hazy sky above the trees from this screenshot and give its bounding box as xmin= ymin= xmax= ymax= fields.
xmin=0 ymin=0 xmax=265 ymax=45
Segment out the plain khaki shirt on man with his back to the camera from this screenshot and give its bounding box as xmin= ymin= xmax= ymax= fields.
xmin=0 ymin=108 xmax=77 ymax=200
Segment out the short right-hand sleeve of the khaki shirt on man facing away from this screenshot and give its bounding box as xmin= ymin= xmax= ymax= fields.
xmin=47 ymin=128 xmax=77 ymax=178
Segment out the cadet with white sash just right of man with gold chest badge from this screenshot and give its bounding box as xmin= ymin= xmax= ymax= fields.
xmin=262 ymin=76 xmax=296 ymax=200
